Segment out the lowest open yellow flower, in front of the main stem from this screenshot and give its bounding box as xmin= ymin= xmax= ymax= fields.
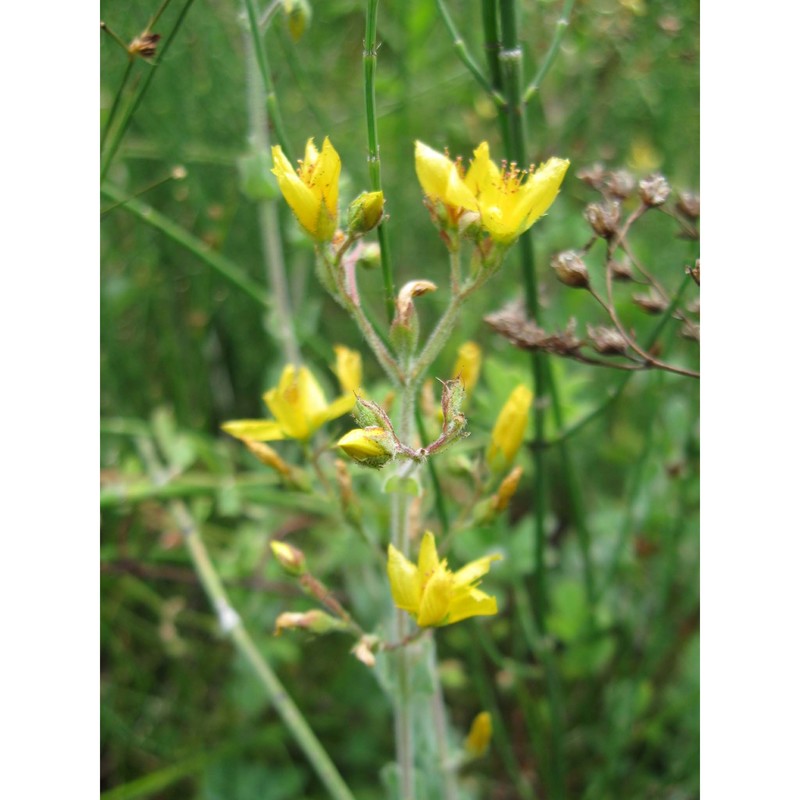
xmin=388 ymin=531 xmax=500 ymax=628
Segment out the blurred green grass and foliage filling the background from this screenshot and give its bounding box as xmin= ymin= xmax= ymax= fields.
xmin=101 ymin=0 xmax=699 ymax=800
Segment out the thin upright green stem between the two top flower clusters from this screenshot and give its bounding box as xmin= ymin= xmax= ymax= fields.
xmin=364 ymin=0 xmax=395 ymax=322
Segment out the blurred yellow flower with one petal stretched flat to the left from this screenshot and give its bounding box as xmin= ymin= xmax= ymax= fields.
xmin=222 ymin=364 xmax=356 ymax=442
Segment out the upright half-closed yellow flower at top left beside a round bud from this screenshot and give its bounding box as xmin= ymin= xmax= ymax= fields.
xmin=272 ymin=136 xmax=342 ymax=242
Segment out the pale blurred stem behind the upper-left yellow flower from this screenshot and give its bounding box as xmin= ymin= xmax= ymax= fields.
xmin=244 ymin=19 xmax=301 ymax=365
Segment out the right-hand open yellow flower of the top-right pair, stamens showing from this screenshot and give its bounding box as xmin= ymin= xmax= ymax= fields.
xmin=464 ymin=142 xmax=569 ymax=244
